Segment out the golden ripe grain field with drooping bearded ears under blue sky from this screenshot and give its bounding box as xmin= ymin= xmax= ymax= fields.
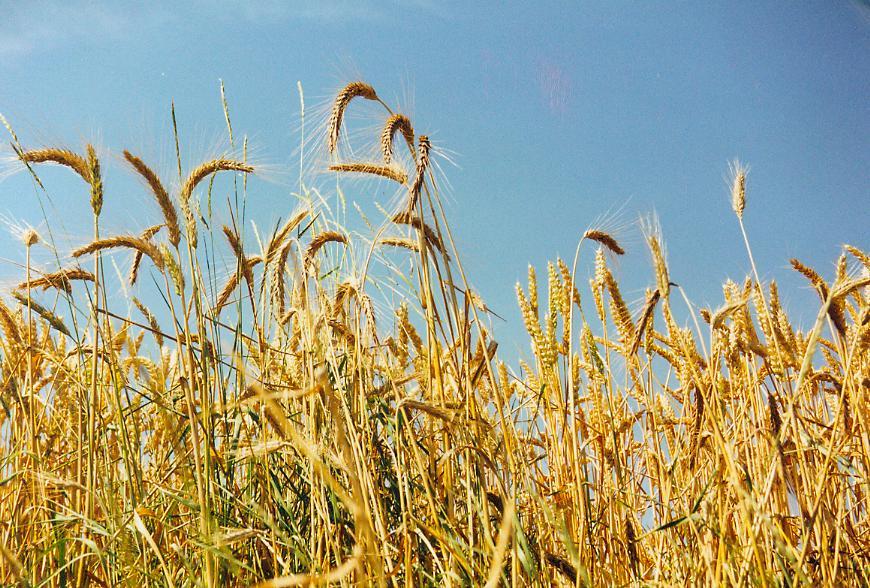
xmin=0 ymin=82 xmax=870 ymax=587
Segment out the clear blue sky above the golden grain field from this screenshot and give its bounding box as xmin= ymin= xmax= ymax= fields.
xmin=0 ymin=0 xmax=870 ymax=358
